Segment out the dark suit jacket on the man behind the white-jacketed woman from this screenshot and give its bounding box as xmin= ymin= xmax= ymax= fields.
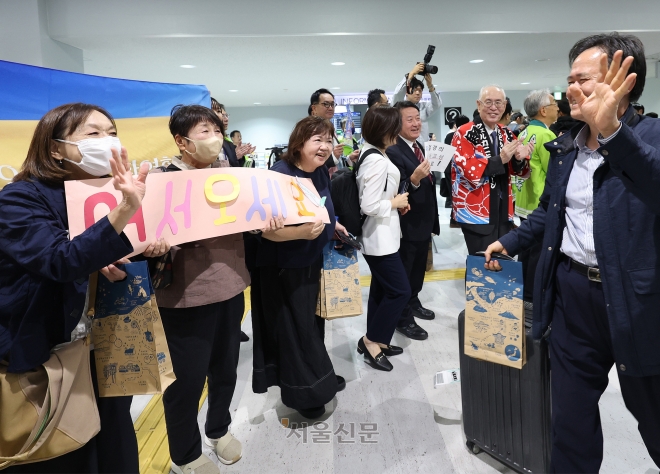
xmin=386 ymin=137 xmax=440 ymax=242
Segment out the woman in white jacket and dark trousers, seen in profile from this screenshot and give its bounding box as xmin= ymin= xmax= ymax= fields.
xmin=356 ymin=107 xmax=410 ymax=371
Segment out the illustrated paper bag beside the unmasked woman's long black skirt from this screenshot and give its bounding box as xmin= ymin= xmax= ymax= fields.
xmin=316 ymin=241 xmax=362 ymax=319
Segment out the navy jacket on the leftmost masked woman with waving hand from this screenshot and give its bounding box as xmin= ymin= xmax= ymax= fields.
xmin=0 ymin=180 xmax=133 ymax=372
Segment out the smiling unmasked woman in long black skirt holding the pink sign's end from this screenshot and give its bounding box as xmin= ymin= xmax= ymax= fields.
xmin=251 ymin=116 xmax=347 ymax=418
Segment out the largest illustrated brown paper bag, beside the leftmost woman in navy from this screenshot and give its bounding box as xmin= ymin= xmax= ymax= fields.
xmin=92 ymin=262 xmax=176 ymax=397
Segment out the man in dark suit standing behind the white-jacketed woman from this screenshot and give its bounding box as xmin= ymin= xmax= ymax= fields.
xmin=387 ymin=101 xmax=440 ymax=340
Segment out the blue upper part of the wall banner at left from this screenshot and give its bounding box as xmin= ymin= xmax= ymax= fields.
xmin=0 ymin=61 xmax=211 ymax=120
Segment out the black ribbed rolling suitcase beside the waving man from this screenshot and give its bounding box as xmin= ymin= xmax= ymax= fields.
xmin=458 ymin=311 xmax=551 ymax=473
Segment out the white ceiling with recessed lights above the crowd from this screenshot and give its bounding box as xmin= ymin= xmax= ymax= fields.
xmin=42 ymin=0 xmax=660 ymax=108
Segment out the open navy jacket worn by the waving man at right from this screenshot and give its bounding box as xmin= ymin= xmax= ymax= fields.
xmin=500 ymin=107 xmax=660 ymax=376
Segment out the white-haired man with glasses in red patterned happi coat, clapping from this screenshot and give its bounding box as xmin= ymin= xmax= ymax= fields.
xmin=451 ymin=85 xmax=531 ymax=255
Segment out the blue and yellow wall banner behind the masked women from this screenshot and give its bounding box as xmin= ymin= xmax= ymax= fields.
xmin=0 ymin=61 xmax=211 ymax=188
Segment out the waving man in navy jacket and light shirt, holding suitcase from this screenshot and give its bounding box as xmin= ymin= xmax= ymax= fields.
xmin=486 ymin=33 xmax=660 ymax=473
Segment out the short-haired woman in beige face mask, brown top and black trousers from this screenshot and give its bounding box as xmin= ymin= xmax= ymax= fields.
xmin=154 ymin=105 xmax=282 ymax=474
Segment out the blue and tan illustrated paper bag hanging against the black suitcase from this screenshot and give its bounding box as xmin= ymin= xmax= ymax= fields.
xmin=464 ymin=255 xmax=525 ymax=369
